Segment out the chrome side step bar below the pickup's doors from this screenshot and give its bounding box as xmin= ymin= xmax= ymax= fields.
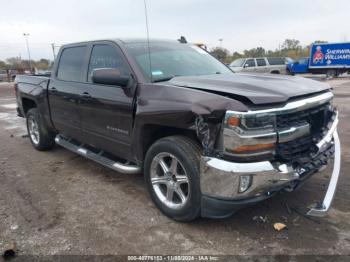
xmin=55 ymin=135 xmax=141 ymax=174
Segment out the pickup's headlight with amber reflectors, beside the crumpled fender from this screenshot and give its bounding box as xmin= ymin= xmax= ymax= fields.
xmin=223 ymin=111 xmax=277 ymax=157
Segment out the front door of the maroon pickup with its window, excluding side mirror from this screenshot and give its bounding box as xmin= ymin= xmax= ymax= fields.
xmin=79 ymin=41 xmax=134 ymax=159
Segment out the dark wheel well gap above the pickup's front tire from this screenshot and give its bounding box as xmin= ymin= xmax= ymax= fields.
xmin=142 ymin=125 xmax=200 ymax=160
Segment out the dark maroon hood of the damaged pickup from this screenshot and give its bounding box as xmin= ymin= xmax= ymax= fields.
xmin=169 ymin=73 xmax=330 ymax=105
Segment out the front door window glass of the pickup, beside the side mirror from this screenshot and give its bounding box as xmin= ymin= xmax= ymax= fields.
xmin=88 ymin=44 xmax=130 ymax=82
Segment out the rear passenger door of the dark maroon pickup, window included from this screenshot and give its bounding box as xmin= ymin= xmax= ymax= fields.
xmin=48 ymin=45 xmax=88 ymax=140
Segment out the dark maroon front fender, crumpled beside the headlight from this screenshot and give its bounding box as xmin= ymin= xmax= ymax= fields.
xmin=132 ymin=84 xmax=248 ymax=161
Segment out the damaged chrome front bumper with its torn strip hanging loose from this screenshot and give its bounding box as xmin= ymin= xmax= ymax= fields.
xmin=200 ymin=124 xmax=341 ymax=218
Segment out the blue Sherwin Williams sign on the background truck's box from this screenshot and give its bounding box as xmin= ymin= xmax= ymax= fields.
xmin=310 ymin=43 xmax=350 ymax=68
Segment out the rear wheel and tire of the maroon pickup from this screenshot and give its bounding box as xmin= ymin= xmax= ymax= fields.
xmin=26 ymin=108 xmax=55 ymax=151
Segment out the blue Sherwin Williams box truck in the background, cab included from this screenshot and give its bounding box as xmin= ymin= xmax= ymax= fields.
xmin=287 ymin=43 xmax=350 ymax=77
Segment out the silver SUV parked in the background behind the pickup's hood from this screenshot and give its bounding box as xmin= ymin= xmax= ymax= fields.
xmin=229 ymin=57 xmax=290 ymax=74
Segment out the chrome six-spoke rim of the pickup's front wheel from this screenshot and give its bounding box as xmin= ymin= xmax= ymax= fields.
xmin=151 ymin=153 xmax=190 ymax=209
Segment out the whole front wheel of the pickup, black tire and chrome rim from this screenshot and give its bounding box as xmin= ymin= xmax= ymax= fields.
xmin=144 ymin=136 xmax=202 ymax=222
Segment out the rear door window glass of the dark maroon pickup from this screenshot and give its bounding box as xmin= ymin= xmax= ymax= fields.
xmin=57 ymin=46 xmax=87 ymax=82
